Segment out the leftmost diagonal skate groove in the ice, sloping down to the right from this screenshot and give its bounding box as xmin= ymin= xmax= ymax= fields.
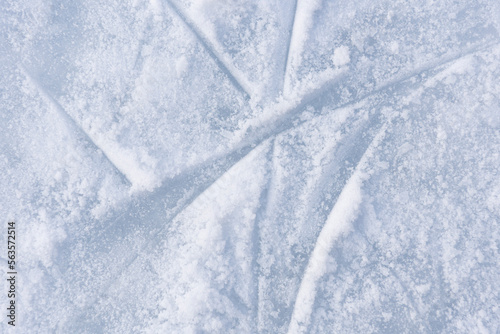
xmin=18 ymin=64 xmax=132 ymax=186
